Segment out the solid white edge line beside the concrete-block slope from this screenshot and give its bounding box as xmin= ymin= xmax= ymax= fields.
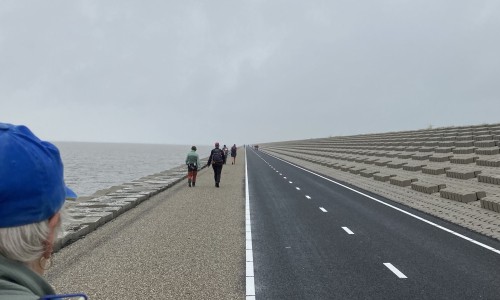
xmin=266 ymin=153 xmax=500 ymax=254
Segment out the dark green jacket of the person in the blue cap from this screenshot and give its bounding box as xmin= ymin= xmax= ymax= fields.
xmin=0 ymin=255 xmax=55 ymax=300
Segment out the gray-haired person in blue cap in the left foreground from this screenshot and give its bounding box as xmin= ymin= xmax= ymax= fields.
xmin=0 ymin=123 xmax=76 ymax=299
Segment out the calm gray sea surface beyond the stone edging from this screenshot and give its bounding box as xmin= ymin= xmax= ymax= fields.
xmin=54 ymin=142 xmax=211 ymax=196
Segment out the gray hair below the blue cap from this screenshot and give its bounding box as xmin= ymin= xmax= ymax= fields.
xmin=0 ymin=220 xmax=50 ymax=264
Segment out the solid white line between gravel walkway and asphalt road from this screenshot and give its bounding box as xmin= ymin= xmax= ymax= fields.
xmin=245 ymin=148 xmax=255 ymax=300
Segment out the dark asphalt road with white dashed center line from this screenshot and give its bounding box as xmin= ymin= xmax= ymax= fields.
xmin=247 ymin=148 xmax=500 ymax=300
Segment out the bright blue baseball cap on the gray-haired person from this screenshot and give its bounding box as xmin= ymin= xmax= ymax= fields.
xmin=0 ymin=123 xmax=77 ymax=228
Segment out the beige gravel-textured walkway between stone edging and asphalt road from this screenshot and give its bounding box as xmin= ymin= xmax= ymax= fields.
xmin=47 ymin=156 xmax=245 ymax=299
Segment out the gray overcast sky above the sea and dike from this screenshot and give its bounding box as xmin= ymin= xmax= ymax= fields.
xmin=0 ymin=0 xmax=500 ymax=145
